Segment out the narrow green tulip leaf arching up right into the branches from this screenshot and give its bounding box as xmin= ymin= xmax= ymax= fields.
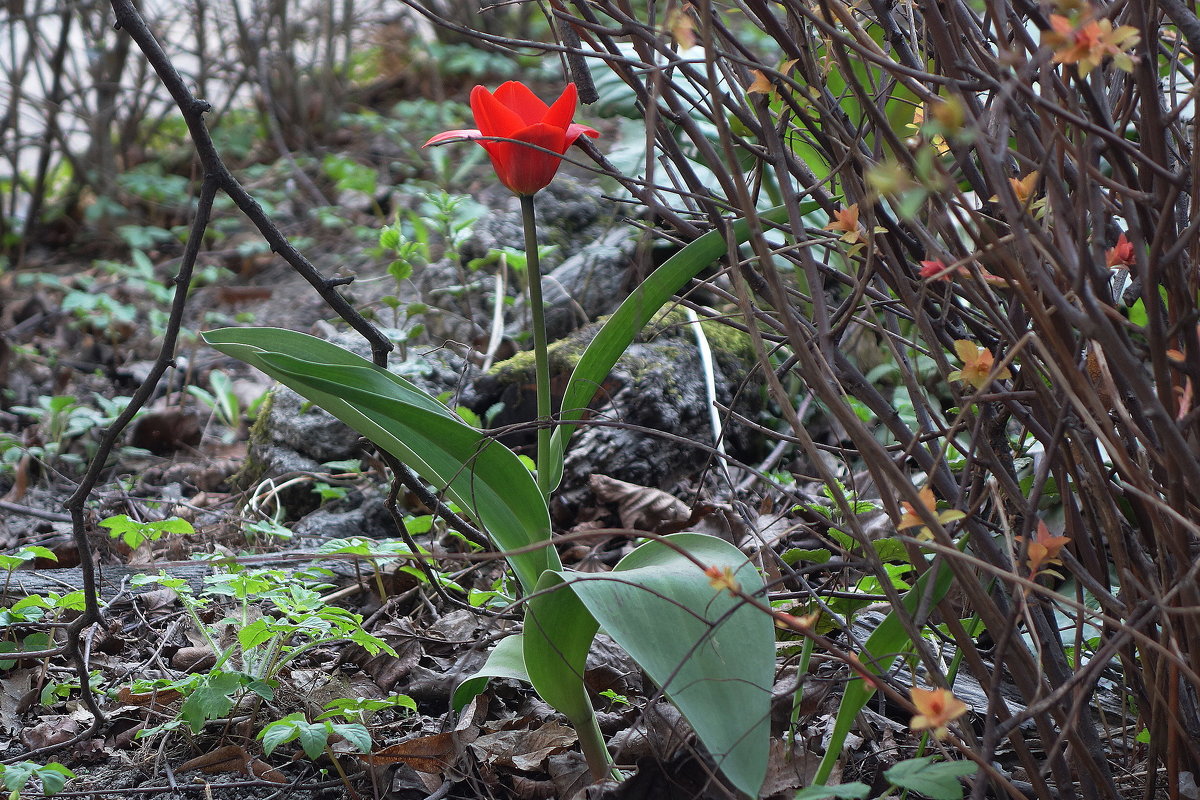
xmin=550 ymin=203 xmax=820 ymax=487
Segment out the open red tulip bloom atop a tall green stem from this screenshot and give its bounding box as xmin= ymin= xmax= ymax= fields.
xmin=425 ymin=80 xmax=600 ymax=194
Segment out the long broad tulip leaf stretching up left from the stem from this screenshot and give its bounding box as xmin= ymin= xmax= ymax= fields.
xmin=204 ymin=327 xmax=560 ymax=590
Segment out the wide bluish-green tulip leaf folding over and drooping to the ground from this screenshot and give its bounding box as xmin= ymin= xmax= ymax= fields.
xmin=524 ymin=534 xmax=775 ymax=796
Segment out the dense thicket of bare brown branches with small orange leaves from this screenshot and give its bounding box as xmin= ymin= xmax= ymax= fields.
xmin=408 ymin=0 xmax=1200 ymax=798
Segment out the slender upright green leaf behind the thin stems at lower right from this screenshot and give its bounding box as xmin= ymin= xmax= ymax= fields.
xmin=812 ymin=561 xmax=954 ymax=783
